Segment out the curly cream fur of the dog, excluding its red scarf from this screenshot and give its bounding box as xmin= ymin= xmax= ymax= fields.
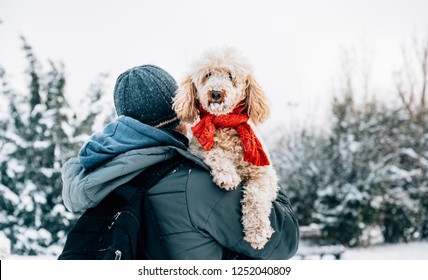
xmin=174 ymin=47 xmax=278 ymax=249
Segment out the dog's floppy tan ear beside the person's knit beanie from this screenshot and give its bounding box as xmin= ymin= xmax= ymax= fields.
xmin=173 ymin=76 xmax=199 ymax=123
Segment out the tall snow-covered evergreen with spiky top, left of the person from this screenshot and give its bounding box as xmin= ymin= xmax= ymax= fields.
xmin=1 ymin=39 xmax=72 ymax=254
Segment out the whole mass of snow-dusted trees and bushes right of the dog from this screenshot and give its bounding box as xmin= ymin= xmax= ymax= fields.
xmin=273 ymin=34 xmax=428 ymax=246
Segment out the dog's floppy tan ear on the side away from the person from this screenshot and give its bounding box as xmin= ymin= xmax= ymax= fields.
xmin=245 ymin=74 xmax=270 ymax=125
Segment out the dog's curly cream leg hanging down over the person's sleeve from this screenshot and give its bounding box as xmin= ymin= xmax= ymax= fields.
xmin=242 ymin=166 xmax=278 ymax=249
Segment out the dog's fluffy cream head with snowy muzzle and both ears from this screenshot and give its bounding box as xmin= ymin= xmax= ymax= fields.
xmin=174 ymin=48 xmax=269 ymax=124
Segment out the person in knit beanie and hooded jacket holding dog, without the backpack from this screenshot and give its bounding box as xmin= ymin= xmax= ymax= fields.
xmin=62 ymin=65 xmax=298 ymax=260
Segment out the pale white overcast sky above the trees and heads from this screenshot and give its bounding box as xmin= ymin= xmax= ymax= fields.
xmin=0 ymin=0 xmax=428 ymax=128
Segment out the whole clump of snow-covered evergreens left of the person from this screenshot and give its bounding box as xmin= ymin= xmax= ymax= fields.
xmin=0 ymin=39 xmax=112 ymax=254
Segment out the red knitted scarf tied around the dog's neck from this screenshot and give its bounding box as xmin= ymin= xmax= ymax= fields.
xmin=192 ymin=105 xmax=270 ymax=166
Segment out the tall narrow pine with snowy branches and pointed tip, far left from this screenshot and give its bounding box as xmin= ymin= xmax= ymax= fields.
xmin=1 ymin=38 xmax=72 ymax=254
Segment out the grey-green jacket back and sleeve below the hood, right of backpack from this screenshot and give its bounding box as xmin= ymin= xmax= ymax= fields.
xmin=144 ymin=161 xmax=298 ymax=259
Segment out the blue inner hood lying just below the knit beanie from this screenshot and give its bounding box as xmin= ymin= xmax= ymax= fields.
xmin=79 ymin=116 xmax=187 ymax=169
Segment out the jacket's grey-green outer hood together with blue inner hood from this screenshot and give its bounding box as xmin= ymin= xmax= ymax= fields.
xmin=61 ymin=117 xmax=209 ymax=212
